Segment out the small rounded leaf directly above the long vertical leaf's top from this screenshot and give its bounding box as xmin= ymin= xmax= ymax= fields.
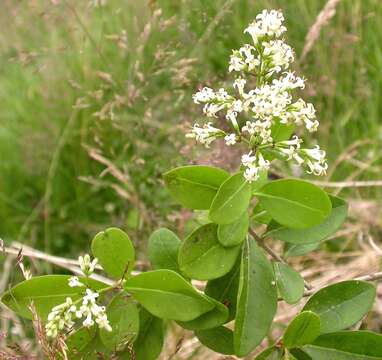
xmin=218 ymin=212 xmax=249 ymax=247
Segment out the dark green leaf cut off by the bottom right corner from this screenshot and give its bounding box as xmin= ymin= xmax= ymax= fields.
xmin=303 ymin=331 xmax=382 ymax=360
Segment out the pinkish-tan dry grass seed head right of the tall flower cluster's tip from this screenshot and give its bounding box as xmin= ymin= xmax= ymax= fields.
xmin=300 ymin=0 xmax=341 ymax=61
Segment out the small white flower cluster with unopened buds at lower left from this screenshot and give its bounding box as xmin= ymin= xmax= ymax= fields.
xmin=45 ymin=254 xmax=112 ymax=338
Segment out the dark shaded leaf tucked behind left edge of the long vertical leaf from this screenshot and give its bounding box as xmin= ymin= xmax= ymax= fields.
xmin=204 ymin=261 xmax=240 ymax=321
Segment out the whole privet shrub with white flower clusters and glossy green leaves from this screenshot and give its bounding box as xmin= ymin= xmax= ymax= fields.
xmin=2 ymin=10 xmax=382 ymax=360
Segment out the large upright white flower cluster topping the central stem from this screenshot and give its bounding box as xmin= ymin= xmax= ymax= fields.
xmin=190 ymin=10 xmax=328 ymax=181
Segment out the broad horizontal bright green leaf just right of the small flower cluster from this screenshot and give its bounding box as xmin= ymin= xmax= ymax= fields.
xmin=125 ymin=270 xmax=215 ymax=321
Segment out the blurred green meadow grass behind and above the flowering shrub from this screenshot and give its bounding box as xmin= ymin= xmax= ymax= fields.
xmin=0 ymin=0 xmax=382 ymax=262
